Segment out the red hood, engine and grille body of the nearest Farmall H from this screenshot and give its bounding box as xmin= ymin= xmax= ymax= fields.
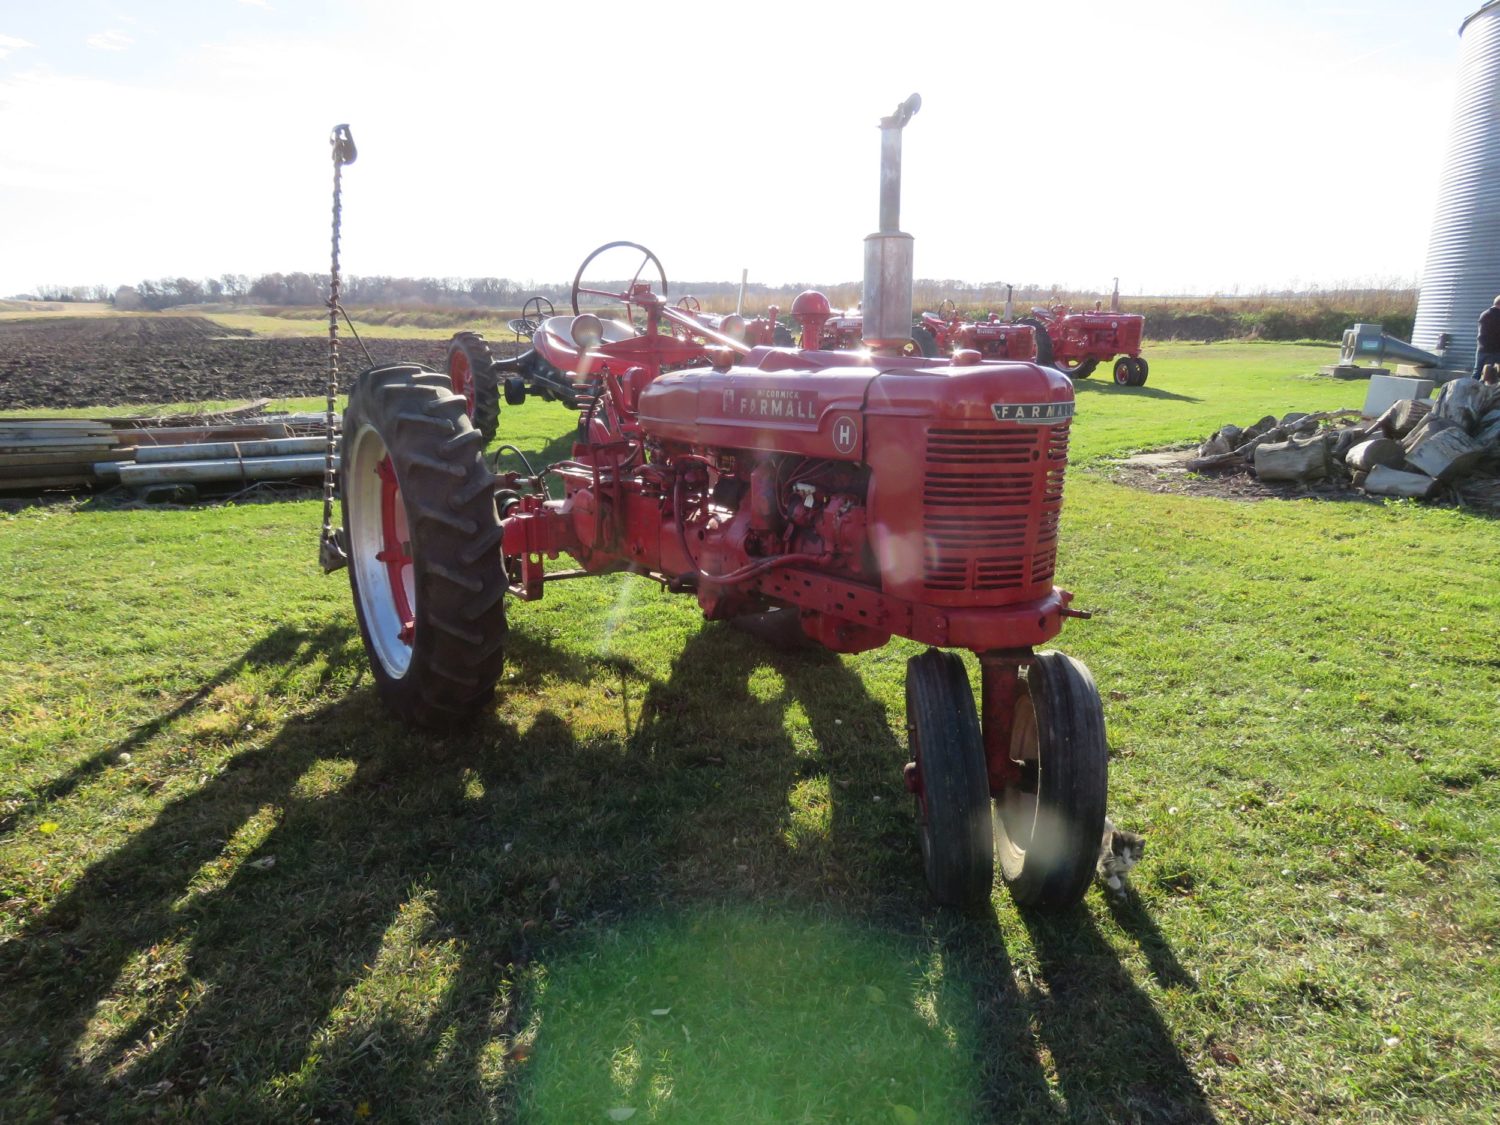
xmin=534 ymin=348 xmax=1074 ymax=651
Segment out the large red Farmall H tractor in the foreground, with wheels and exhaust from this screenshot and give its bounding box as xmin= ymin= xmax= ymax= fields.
xmin=342 ymin=96 xmax=1107 ymax=908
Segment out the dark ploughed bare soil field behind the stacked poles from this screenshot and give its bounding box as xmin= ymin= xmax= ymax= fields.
xmin=0 ymin=317 xmax=510 ymax=410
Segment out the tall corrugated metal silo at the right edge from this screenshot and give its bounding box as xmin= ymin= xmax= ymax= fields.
xmin=1412 ymin=0 xmax=1500 ymax=368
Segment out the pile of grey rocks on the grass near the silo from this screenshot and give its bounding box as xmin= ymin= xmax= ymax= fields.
xmin=1187 ymin=380 xmax=1500 ymax=500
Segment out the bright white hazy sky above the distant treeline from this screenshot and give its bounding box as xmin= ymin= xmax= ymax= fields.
xmin=0 ymin=0 xmax=1481 ymax=294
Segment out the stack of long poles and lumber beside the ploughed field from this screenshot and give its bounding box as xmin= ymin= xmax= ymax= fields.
xmin=0 ymin=399 xmax=340 ymax=492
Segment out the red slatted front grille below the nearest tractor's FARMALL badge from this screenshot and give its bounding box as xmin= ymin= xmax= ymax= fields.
xmin=923 ymin=422 xmax=1068 ymax=593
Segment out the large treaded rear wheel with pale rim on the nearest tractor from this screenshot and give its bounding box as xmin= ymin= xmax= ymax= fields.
xmin=342 ymin=363 xmax=507 ymax=729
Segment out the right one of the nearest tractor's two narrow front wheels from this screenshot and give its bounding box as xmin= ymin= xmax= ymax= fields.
xmin=995 ymin=653 xmax=1109 ymax=911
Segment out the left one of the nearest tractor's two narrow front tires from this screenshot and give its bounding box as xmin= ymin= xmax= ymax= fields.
xmin=906 ymin=648 xmax=995 ymax=909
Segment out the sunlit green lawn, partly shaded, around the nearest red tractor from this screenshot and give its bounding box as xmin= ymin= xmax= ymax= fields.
xmin=0 ymin=345 xmax=1500 ymax=1122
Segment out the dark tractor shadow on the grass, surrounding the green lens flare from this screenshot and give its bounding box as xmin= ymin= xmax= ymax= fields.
xmin=0 ymin=624 xmax=1211 ymax=1121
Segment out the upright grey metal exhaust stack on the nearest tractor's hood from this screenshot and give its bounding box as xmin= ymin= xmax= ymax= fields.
xmin=863 ymin=95 xmax=923 ymax=354
